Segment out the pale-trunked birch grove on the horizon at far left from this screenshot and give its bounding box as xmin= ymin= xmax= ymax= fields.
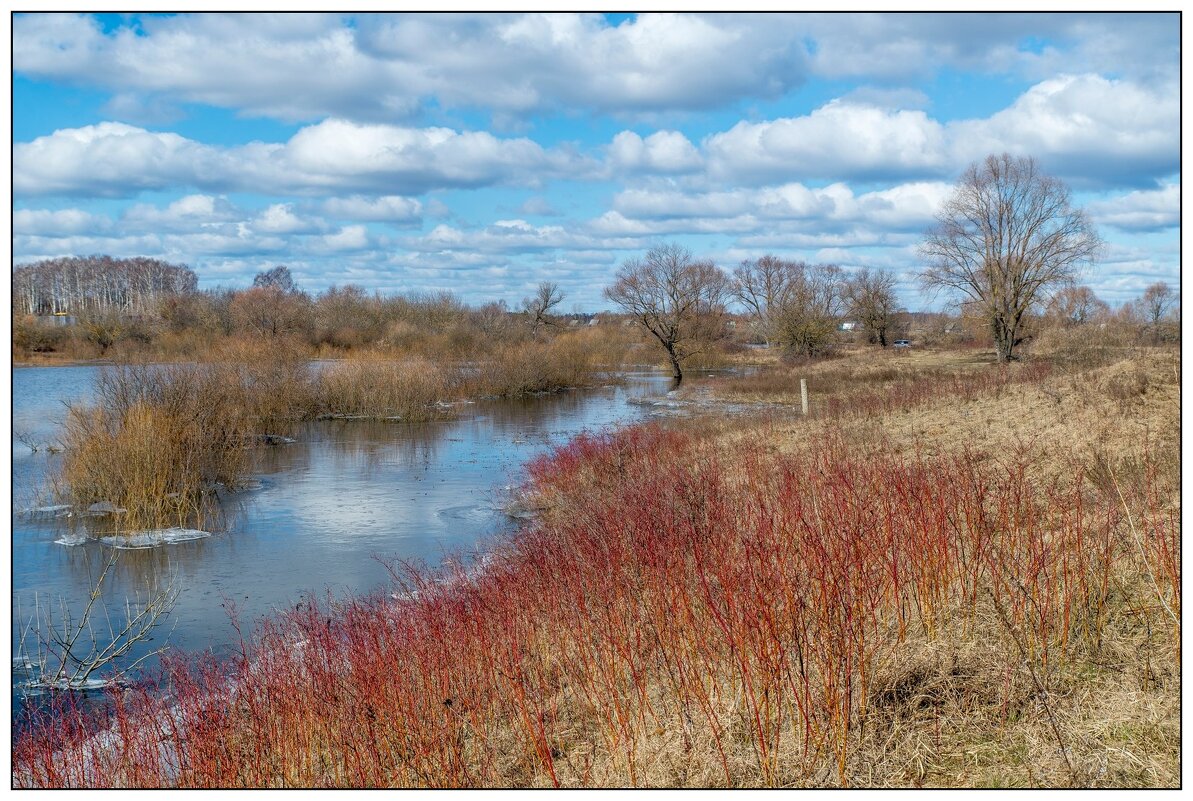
xmin=12 ymin=255 xmax=198 ymax=316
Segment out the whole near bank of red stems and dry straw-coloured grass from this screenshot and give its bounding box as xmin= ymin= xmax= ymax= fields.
xmin=16 ymin=350 xmax=1180 ymax=787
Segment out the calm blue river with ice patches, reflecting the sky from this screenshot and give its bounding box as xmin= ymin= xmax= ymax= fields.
xmin=12 ymin=366 xmax=669 ymax=706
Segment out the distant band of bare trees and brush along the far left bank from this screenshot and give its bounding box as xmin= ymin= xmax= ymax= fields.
xmin=13 ymin=257 xmax=633 ymax=359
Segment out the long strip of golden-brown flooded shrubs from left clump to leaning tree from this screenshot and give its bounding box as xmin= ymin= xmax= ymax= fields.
xmin=37 ymin=335 xmax=634 ymax=535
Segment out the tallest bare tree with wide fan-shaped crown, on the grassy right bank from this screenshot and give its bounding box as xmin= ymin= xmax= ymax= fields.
xmin=920 ymin=153 xmax=1101 ymax=362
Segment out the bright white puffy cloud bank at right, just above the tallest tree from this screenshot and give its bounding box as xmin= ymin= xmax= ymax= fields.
xmin=703 ymin=75 xmax=1180 ymax=186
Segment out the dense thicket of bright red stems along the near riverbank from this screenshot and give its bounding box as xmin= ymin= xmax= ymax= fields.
xmin=14 ymin=427 xmax=1180 ymax=787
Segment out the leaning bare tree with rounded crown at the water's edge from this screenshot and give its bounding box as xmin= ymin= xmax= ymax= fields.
xmin=605 ymin=245 xmax=729 ymax=381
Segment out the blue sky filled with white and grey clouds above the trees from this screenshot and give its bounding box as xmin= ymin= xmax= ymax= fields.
xmin=12 ymin=12 xmax=1180 ymax=312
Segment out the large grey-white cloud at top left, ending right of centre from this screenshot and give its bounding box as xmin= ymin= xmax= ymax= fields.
xmin=13 ymin=13 xmax=805 ymax=122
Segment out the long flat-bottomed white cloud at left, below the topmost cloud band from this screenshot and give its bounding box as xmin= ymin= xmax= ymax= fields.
xmin=13 ymin=119 xmax=592 ymax=197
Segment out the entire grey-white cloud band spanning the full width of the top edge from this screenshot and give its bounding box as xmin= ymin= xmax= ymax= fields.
xmin=13 ymin=13 xmax=1180 ymax=122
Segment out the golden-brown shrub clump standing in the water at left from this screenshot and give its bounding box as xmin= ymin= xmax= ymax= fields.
xmin=55 ymin=351 xmax=310 ymax=531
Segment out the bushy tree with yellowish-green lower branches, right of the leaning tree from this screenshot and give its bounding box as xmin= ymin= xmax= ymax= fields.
xmin=774 ymin=264 xmax=845 ymax=358
